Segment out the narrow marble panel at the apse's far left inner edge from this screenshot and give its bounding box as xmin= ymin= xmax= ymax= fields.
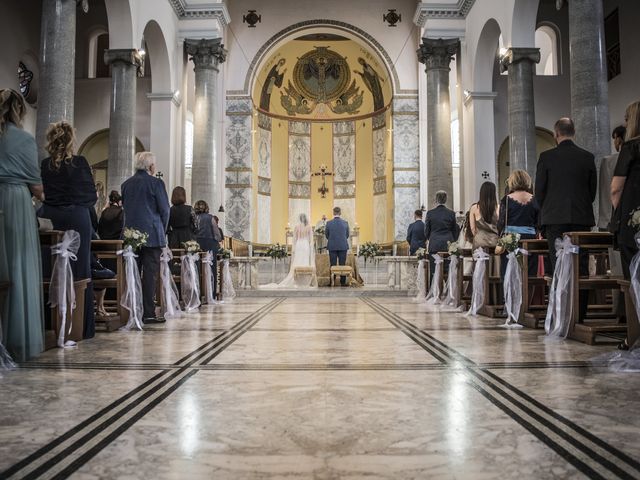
xmin=256 ymin=113 xmax=271 ymax=243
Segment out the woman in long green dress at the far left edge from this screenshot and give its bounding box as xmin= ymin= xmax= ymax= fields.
xmin=0 ymin=89 xmax=44 ymax=362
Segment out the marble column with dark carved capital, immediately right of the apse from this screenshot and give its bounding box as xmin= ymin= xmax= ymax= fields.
xmin=418 ymin=38 xmax=460 ymax=207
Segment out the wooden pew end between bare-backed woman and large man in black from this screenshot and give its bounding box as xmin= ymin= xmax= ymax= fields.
xmin=518 ymin=239 xmax=549 ymax=328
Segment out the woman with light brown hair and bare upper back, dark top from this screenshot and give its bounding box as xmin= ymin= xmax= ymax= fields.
xmin=498 ymin=170 xmax=540 ymax=278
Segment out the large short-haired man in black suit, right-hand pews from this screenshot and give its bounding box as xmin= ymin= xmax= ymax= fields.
xmin=535 ymin=118 xmax=598 ymax=319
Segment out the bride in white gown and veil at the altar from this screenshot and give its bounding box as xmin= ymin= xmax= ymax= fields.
xmin=274 ymin=213 xmax=318 ymax=288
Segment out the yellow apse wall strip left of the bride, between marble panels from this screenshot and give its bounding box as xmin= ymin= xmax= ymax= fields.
xmin=271 ymin=119 xmax=289 ymax=243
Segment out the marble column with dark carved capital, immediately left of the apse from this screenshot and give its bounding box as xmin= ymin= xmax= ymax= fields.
xmin=185 ymin=38 xmax=227 ymax=208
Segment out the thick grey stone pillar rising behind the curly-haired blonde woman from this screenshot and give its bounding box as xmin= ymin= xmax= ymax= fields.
xmin=36 ymin=0 xmax=76 ymax=158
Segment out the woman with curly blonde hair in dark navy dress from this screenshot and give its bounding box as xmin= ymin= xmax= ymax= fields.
xmin=39 ymin=121 xmax=98 ymax=338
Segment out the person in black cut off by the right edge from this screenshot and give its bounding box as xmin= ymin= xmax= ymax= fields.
xmin=611 ymin=101 xmax=640 ymax=349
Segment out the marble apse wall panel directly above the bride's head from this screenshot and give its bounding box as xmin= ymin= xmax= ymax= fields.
xmin=289 ymin=122 xmax=311 ymax=228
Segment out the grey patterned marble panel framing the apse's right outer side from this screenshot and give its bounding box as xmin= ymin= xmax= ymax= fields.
xmin=393 ymin=96 xmax=420 ymax=240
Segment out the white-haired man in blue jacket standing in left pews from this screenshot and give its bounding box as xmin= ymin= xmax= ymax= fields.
xmin=121 ymin=152 xmax=169 ymax=323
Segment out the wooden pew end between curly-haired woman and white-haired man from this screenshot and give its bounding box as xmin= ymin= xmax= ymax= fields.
xmin=91 ymin=240 xmax=129 ymax=332
